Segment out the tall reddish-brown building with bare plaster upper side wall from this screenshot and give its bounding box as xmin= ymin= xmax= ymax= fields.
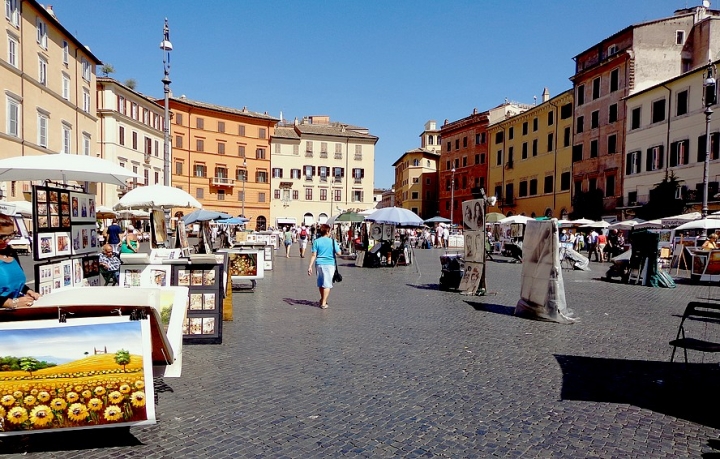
xmin=570 ymin=6 xmax=719 ymax=218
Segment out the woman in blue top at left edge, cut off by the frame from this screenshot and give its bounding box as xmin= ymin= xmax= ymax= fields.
xmin=0 ymin=214 xmax=40 ymax=309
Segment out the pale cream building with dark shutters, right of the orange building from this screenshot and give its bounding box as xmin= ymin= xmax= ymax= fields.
xmin=270 ymin=116 xmax=378 ymax=226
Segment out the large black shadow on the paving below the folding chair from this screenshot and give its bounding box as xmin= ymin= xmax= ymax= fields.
xmin=555 ymin=356 xmax=720 ymax=432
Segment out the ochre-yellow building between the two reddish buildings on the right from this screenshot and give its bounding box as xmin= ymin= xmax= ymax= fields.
xmin=487 ymin=88 xmax=573 ymax=218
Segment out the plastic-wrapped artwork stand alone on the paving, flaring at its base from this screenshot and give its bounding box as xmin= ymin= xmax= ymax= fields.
xmin=515 ymin=219 xmax=577 ymax=324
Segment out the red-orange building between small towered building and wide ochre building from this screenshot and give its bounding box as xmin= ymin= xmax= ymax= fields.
xmin=438 ymin=101 xmax=532 ymax=224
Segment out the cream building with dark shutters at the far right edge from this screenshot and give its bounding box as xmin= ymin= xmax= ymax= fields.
xmin=622 ymin=62 xmax=720 ymax=217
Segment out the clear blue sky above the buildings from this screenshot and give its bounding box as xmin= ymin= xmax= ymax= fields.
xmin=49 ymin=0 xmax=696 ymax=188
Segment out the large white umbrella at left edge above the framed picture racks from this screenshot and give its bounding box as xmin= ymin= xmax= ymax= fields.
xmin=0 ymin=153 xmax=140 ymax=186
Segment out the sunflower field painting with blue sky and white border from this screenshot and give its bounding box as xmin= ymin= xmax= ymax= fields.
xmin=0 ymin=316 xmax=155 ymax=437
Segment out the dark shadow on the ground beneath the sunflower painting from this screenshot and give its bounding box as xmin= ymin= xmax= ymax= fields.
xmin=0 ymin=427 xmax=143 ymax=456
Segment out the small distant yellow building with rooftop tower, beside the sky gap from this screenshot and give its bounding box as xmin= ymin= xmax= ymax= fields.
xmin=393 ymin=148 xmax=440 ymax=220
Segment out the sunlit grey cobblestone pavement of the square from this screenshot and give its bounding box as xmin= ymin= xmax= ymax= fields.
xmin=0 ymin=247 xmax=720 ymax=458
